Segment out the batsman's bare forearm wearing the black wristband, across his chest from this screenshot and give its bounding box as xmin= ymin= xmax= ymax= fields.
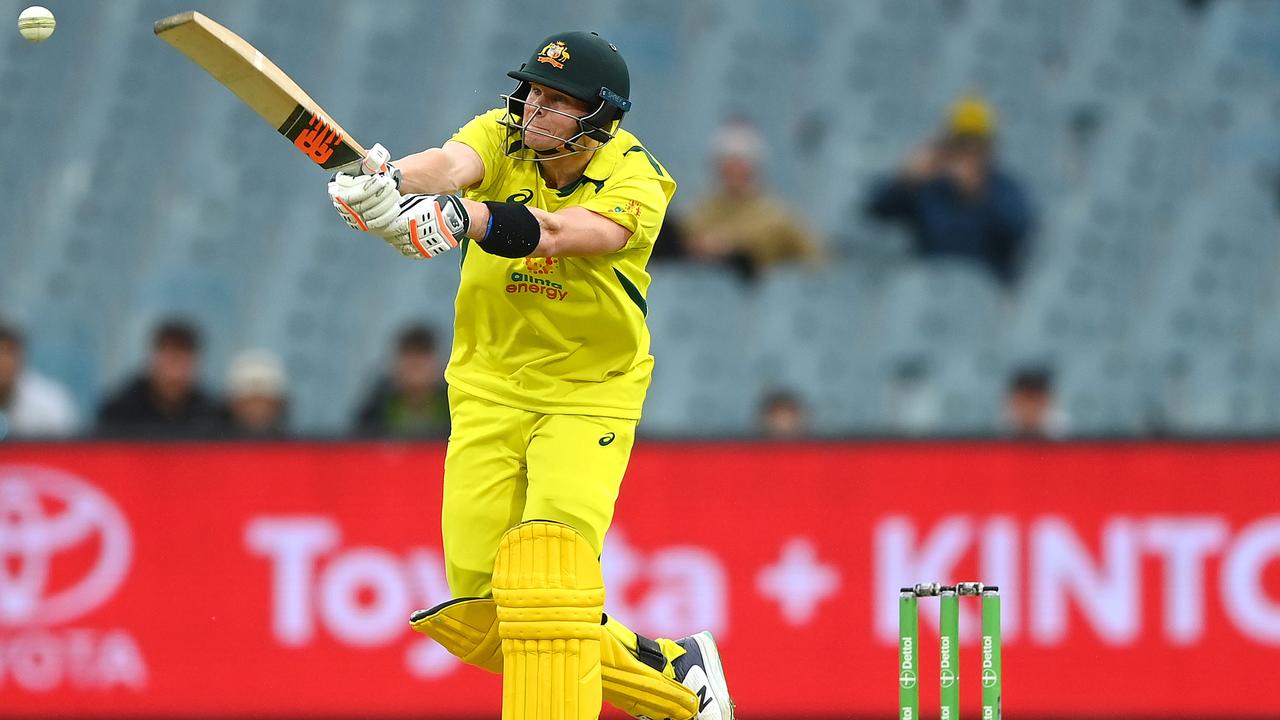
xmin=462 ymin=200 xmax=631 ymax=258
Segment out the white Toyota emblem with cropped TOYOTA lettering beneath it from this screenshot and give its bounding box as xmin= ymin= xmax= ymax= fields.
xmin=0 ymin=465 xmax=146 ymax=692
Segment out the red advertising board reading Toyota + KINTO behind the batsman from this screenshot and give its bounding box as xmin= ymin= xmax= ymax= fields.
xmin=0 ymin=443 xmax=1280 ymax=717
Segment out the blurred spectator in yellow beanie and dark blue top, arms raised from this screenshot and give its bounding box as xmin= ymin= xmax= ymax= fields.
xmin=867 ymin=97 xmax=1034 ymax=284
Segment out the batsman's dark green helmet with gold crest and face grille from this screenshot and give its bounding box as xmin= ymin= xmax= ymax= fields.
xmin=502 ymin=32 xmax=631 ymax=152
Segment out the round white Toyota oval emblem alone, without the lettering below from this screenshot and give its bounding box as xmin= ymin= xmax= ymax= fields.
xmin=0 ymin=465 xmax=133 ymax=628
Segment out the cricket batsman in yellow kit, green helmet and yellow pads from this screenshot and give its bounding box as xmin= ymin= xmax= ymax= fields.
xmin=329 ymin=32 xmax=733 ymax=720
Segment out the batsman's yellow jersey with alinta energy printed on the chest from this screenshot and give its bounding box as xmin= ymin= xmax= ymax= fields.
xmin=444 ymin=109 xmax=676 ymax=419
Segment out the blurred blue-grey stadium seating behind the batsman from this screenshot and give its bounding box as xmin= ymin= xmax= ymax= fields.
xmin=0 ymin=0 xmax=1280 ymax=437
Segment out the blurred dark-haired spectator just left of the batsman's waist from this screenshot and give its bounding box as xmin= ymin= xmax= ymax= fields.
xmin=358 ymin=325 xmax=449 ymax=438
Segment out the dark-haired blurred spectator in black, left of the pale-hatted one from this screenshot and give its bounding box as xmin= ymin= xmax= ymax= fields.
xmin=97 ymin=320 xmax=220 ymax=437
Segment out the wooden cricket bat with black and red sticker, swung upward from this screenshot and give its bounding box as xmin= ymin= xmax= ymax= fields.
xmin=155 ymin=10 xmax=390 ymax=173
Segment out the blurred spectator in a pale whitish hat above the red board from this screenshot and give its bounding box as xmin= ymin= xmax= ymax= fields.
xmin=227 ymin=350 xmax=287 ymax=439
